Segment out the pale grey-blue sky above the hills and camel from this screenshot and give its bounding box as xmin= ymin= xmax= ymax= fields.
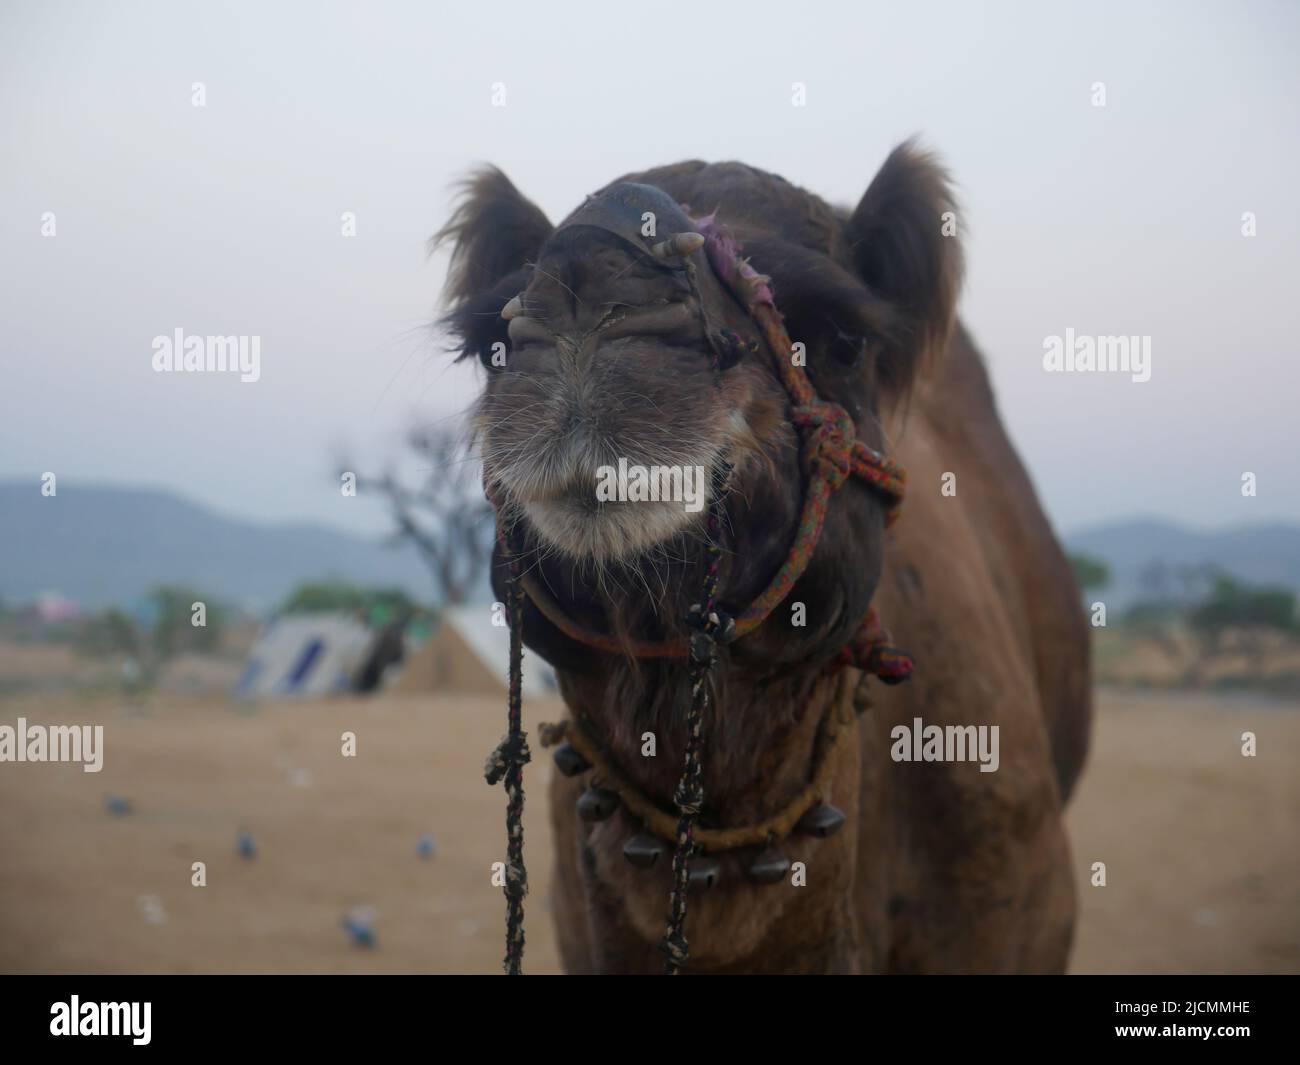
xmin=0 ymin=0 xmax=1300 ymax=532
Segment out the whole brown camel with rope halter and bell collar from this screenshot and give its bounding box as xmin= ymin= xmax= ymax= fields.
xmin=434 ymin=142 xmax=1091 ymax=974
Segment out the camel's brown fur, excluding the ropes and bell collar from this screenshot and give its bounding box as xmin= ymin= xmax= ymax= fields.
xmin=434 ymin=146 xmax=1089 ymax=973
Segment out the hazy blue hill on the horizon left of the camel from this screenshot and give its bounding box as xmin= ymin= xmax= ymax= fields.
xmin=0 ymin=481 xmax=433 ymax=610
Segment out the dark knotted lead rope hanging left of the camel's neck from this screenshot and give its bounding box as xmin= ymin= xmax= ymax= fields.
xmin=484 ymin=536 xmax=532 ymax=977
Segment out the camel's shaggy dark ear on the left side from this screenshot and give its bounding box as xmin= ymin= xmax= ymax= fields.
xmin=429 ymin=166 xmax=551 ymax=358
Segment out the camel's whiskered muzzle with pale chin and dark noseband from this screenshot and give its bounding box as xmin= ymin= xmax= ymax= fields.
xmin=477 ymin=210 xmax=779 ymax=574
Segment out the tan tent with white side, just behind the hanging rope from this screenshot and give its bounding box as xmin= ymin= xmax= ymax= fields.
xmin=393 ymin=603 xmax=558 ymax=698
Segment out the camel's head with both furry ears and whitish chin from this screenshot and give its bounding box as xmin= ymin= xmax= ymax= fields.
xmin=434 ymin=144 xmax=961 ymax=665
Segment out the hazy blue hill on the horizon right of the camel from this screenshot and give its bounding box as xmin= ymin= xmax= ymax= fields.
xmin=1065 ymin=519 xmax=1300 ymax=605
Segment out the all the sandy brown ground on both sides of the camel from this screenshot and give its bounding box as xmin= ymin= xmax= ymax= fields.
xmin=0 ymin=692 xmax=1300 ymax=973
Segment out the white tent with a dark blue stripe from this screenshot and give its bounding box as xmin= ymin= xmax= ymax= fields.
xmin=235 ymin=614 xmax=376 ymax=698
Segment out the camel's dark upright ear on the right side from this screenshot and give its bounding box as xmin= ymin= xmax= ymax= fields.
xmin=846 ymin=140 xmax=962 ymax=394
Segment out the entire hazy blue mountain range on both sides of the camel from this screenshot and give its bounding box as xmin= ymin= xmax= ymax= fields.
xmin=0 ymin=481 xmax=1300 ymax=610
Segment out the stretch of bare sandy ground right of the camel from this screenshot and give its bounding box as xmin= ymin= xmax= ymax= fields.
xmin=1067 ymin=690 xmax=1300 ymax=973
